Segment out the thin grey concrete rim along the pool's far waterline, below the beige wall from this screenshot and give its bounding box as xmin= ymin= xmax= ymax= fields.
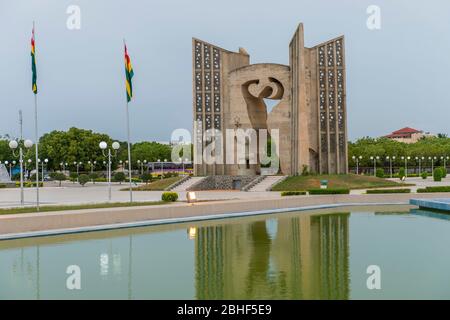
xmin=0 ymin=201 xmax=409 ymax=241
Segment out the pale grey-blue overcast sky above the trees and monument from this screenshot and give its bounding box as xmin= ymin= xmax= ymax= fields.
xmin=0 ymin=0 xmax=450 ymax=141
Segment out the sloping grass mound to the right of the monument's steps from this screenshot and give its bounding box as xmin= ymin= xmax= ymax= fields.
xmin=272 ymin=174 xmax=411 ymax=191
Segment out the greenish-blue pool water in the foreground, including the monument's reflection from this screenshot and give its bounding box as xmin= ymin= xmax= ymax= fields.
xmin=0 ymin=206 xmax=450 ymax=299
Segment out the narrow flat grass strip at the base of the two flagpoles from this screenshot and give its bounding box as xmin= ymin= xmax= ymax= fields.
xmin=0 ymin=201 xmax=170 ymax=215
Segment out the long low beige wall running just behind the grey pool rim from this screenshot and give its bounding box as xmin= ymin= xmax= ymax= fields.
xmin=0 ymin=194 xmax=448 ymax=235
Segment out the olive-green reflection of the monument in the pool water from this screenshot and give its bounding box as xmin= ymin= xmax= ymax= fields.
xmin=195 ymin=213 xmax=349 ymax=299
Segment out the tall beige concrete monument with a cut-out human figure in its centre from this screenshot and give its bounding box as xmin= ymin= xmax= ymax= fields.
xmin=192 ymin=24 xmax=348 ymax=176
